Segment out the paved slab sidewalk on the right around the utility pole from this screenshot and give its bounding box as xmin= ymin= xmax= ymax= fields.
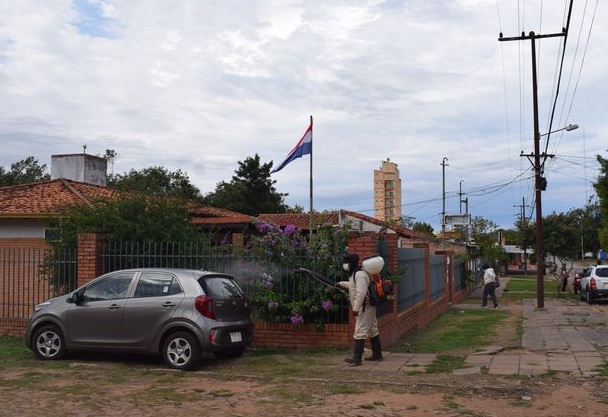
xmin=346 ymin=280 xmax=608 ymax=375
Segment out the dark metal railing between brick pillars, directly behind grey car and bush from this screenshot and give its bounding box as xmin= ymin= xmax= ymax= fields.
xmin=101 ymin=242 xmax=349 ymax=326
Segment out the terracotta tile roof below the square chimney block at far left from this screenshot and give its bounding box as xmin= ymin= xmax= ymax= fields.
xmin=0 ymin=178 xmax=116 ymax=218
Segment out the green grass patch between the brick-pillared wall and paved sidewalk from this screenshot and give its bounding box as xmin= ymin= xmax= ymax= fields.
xmin=391 ymin=309 xmax=509 ymax=353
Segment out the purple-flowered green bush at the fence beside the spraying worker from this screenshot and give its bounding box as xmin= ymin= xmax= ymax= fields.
xmin=247 ymin=221 xmax=349 ymax=330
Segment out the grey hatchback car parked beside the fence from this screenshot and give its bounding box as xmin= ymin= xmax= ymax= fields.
xmin=25 ymin=268 xmax=253 ymax=370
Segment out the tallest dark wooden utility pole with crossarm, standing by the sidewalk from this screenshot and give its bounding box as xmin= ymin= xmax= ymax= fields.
xmin=498 ymin=0 xmax=573 ymax=310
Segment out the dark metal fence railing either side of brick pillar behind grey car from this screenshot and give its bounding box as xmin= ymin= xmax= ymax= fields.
xmin=0 ymin=242 xmax=349 ymax=327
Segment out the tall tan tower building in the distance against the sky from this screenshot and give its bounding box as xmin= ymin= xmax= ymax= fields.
xmin=374 ymin=158 xmax=401 ymax=221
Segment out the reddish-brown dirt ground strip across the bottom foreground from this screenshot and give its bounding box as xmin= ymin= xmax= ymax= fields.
xmin=0 ymin=370 xmax=608 ymax=417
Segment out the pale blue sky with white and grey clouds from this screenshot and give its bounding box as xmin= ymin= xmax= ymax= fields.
xmin=0 ymin=0 xmax=608 ymax=230
